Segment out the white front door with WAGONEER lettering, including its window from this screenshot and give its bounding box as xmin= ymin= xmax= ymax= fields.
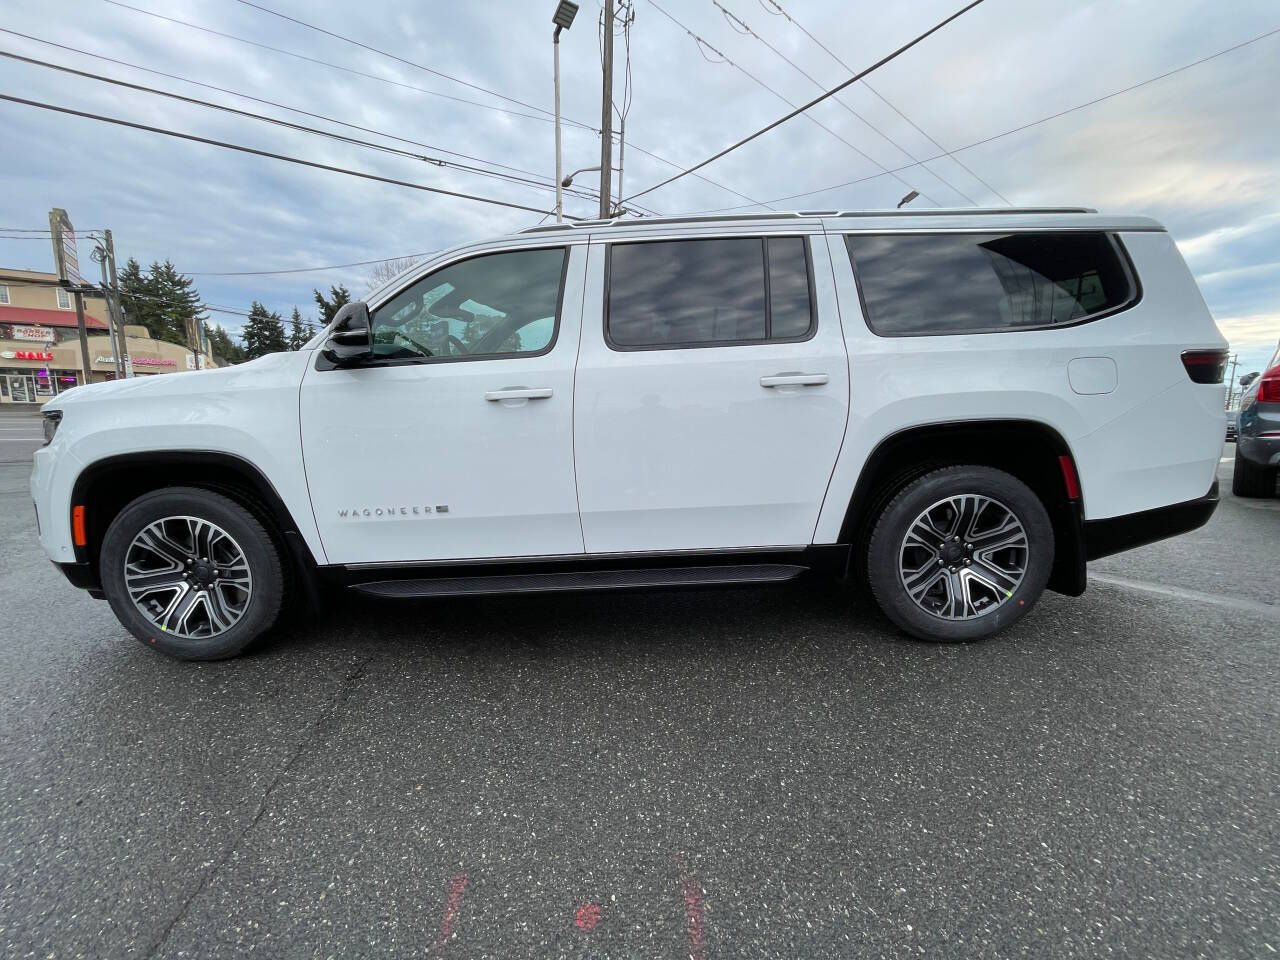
xmin=301 ymin=246 xmax=586 ymax=563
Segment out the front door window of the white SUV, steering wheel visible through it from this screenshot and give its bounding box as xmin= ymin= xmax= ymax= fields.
xmin=372 ymin=247 xmax=567 ymax=360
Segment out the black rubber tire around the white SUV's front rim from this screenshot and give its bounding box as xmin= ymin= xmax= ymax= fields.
xmin=99 ymin=486 xmax=284 ymax=660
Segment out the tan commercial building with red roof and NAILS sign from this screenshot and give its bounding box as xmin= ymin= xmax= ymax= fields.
xmin=0 ymin=268 xmax=216 ymax=403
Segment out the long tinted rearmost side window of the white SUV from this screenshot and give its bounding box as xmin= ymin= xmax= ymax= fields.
xmin=845 ymin=233 xmax=1134 ymax=337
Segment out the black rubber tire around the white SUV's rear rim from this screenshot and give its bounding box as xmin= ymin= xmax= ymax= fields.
xmin=867 ymin=466 xmax=1053 ymax=643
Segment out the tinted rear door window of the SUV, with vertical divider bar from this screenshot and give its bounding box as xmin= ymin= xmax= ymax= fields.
xmin=607 ymin=237 xmax=812 ymax=348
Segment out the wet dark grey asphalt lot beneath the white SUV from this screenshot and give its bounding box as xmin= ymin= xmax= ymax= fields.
xmin=0 ymin=430 xmax=1280 ymax=960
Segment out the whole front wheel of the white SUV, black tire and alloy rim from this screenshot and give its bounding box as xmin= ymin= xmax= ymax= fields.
xmin=99 ymin=488 xmax=283 ymax=660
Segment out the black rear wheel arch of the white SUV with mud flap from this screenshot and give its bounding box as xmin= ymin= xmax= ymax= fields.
xmin=840 ymin=419 xmax=1085 ymax=596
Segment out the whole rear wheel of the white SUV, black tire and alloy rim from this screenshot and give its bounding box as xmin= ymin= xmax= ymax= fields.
xmin=867 ymin=466 xmax=1053 ymax=643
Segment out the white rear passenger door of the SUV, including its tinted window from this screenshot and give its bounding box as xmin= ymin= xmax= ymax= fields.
xmin=573 ymin=232 xmax=849 ymax=553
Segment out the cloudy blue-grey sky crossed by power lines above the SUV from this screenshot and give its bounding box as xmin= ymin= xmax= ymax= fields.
xmin=0 ymin=0 xmax=1280 ymax=381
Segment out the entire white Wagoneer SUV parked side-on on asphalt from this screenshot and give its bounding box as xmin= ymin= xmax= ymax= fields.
xmin=31 ymin=209 xmax=1226 ymax=659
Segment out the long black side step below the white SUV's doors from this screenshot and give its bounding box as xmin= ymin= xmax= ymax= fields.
xmin=351 ymin=563 xmax=808 ymax=596
